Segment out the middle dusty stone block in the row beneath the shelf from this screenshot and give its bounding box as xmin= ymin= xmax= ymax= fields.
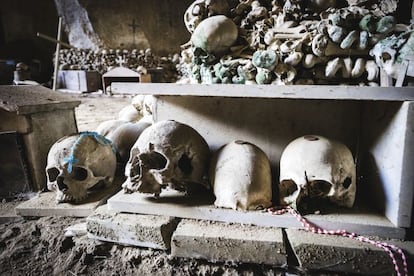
xmin=171 ymin=219 xmax=287 ymax=266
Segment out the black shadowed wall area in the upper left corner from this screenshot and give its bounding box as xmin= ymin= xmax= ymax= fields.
xmin=0 ymin=0 xmax=58 ymax=84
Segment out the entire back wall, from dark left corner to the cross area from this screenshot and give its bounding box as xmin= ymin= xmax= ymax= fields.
xmin=0 ymin=0 xmax=193 ymax=84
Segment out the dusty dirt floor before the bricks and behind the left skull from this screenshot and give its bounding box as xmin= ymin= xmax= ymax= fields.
xmin=0 ymin=93 xmax=296 ymax=276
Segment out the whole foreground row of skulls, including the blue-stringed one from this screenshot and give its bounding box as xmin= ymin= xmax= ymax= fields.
xmin=46 ymin=111 xmax=356 ymax=210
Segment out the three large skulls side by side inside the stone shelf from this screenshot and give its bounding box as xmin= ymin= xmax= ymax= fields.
xmin=118 ymin=120 xmax=356 ymax=210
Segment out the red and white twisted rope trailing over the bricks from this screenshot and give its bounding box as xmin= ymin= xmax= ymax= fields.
xmin=268 ymin=206 xmax=408 ymax=276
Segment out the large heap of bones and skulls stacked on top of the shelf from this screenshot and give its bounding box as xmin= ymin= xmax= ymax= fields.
xmin=180 ymin=0 xmax=413 ymax=85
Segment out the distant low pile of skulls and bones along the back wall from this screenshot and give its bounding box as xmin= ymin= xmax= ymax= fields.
xmin=59 ymin=48 xmax=179 ymax=82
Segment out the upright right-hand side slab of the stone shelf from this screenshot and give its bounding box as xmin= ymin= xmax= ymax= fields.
xmin=360 ymin=102 xmax=414 ymax=228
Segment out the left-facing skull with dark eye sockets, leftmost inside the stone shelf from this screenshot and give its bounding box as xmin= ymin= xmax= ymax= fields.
xmin=122 ymin=120 xmax=210 ymax=196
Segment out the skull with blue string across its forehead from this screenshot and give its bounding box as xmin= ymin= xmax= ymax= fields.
xmin=46 ymin=132 xmax=116 ymax=203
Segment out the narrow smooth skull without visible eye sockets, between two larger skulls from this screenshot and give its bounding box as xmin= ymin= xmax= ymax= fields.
xmin=210 ymin=141 xmax=272 ymax=211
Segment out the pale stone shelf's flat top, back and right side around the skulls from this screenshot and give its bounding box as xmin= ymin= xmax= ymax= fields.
xmin=108 ymin=83 xmax=414 ymax=235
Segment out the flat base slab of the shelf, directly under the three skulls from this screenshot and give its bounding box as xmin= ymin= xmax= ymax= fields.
xmin=108 ymin=189 xmax=405 ymax=239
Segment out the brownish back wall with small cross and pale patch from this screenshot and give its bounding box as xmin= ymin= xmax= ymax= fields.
xmin=55 ymin=0 xmax=193 ymax=54
